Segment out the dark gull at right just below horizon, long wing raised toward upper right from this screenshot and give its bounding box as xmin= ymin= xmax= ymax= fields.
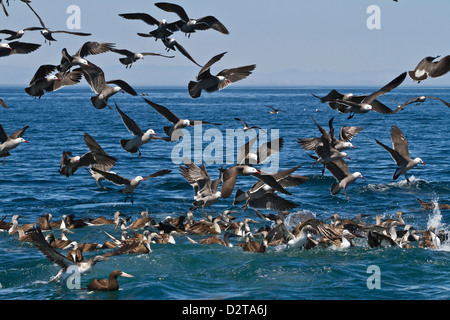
xmin=330 ymin=72 xmax=406 ymax=119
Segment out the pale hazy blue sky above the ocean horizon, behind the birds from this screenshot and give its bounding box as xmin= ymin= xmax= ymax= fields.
xmin=0 ymin=0 xmax=450 ymax=85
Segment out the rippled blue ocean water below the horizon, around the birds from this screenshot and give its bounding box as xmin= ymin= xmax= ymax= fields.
xmin=0 ymin=85 xmax=450 ymax=300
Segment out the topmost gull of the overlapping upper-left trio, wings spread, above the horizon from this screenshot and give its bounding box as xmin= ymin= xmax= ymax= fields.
xmin=58 ymin=41 xmax=115 ymax=72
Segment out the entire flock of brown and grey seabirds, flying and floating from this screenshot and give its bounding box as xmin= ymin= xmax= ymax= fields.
xmin=0 ymin=0 xmax=450 ymax=290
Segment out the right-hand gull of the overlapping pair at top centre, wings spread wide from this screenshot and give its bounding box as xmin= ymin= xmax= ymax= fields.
xmin=155 ymin=2 xmax=230 ymax=37
